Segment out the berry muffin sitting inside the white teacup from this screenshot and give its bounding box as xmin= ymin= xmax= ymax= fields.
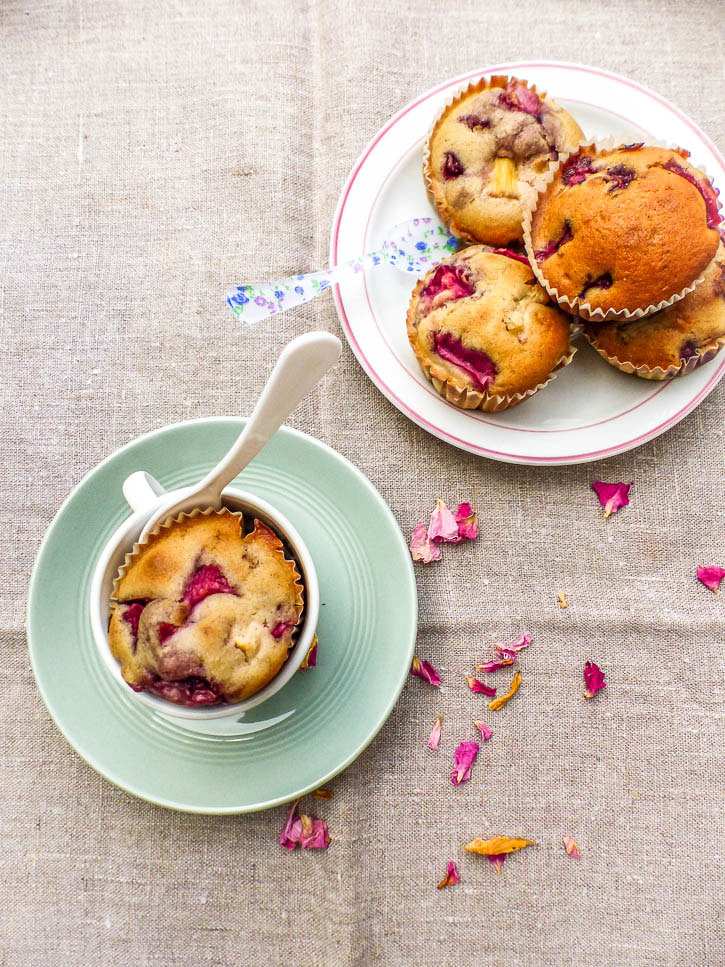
xmin=108 ymin=510 xmax=303 ymax=706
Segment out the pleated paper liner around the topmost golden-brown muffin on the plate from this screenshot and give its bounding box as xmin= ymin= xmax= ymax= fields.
xmin=522 ymin=137 xmax=720 ymax=322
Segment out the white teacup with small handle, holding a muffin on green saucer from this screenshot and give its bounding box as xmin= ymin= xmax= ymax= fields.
xmin=89 ymin=473 xmax=320 ymax=722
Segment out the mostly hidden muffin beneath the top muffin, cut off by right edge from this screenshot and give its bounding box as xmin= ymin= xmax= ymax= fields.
xmin=583 ymin=243 xmax=725 ymax=379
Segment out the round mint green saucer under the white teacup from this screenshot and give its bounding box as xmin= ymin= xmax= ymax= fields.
xmin=28 ymin=419 xmax=417 ymax=813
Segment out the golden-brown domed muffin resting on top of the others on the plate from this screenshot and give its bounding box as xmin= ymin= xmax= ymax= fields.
xmin=525 ymin=144 xmax=721 ymax=320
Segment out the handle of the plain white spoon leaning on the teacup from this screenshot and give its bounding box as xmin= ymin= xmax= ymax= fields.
xmin=198 ymin=332 xmax=342 ymax=504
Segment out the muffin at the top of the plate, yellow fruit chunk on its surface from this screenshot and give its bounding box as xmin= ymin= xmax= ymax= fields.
xmin=423 ymin=77 xmax=584 ymax=245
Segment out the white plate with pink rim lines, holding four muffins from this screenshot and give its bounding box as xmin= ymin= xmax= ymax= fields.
xmin=330 ymin=61 xmax=725 ymax=464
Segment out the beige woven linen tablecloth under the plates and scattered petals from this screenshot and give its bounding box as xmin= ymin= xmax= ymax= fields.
xmin=0 ymin=0 xmax=725 ymax=967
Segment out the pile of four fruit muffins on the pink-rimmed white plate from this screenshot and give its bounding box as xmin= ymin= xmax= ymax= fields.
xmin=407 ymin=77 xmax=725 ymax=412
